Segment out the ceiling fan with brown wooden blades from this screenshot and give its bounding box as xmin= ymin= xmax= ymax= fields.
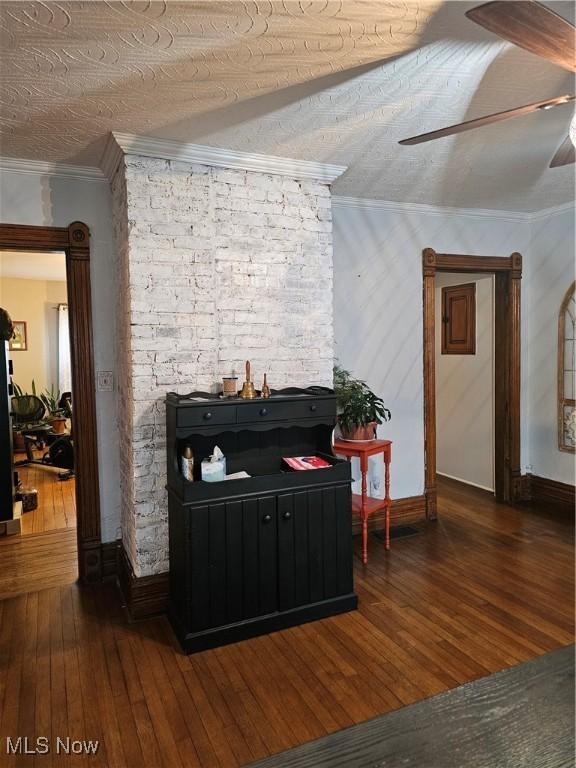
xmin=399 ymin=0 xmax=576 ymax=168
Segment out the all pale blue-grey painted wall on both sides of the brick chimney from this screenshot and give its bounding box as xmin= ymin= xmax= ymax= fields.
xmin=0 ymin=164 xmax=574 ymax=552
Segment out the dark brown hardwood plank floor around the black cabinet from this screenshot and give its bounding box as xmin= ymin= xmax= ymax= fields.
xmin=0 ymin=481 xmax=574 ymax=768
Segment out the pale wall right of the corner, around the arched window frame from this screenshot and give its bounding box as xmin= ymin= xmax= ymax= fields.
xmin=526 ymin=206 xmax=576 ymax=484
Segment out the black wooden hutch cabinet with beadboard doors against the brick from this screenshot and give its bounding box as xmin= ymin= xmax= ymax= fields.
xmin=167 ymin=390 xmax=357 ymax=652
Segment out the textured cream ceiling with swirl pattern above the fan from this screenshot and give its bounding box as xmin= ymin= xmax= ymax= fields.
xmin=0 ymin=0 xmax=574 ymax=211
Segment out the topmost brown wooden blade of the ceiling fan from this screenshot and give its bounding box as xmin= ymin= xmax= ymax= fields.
xmin=466 ymin=0 xmax=576 ymax=72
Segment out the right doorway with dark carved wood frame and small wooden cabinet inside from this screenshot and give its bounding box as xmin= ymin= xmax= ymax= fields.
xmin=422 ymin=248 xmax=522 ymax=519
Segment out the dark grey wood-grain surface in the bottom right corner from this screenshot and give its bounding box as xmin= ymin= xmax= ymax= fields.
xmin=252 ymin=646 xmax=575 ymax=768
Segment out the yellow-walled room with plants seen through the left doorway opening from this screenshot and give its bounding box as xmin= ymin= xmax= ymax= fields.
xmin=0 ymin=250 xmax=76 ymax=536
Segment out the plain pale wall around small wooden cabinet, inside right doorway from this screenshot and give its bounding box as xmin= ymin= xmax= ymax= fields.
xmin=436 ymin=274 xmax=494 ymax=491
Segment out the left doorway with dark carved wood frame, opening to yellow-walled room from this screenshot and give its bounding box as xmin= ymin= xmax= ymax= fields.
xmin=0 ymin=221 xmax=102 ymax=597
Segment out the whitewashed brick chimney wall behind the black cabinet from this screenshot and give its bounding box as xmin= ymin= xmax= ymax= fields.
xmin=112 ymin=156 xmax=333 ymax=576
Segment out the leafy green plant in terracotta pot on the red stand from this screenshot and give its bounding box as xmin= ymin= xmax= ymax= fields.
xmin=334 ymin=365 xmax=391 ymax=440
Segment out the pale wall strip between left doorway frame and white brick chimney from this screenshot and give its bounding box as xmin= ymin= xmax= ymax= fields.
xmin=0 ymin=171 xmax=120 ymax=541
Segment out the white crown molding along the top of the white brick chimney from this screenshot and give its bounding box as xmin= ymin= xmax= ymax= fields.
xmin=100 ymin=133 xmax=346 ymax=184
